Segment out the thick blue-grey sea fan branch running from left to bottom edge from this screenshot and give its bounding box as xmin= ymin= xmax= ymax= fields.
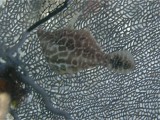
xmin=7 ymin=56 xmax=73 ymax=120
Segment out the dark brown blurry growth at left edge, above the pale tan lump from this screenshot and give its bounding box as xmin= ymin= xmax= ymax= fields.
xmin=0 ymin=67 xmax=26 ymax=113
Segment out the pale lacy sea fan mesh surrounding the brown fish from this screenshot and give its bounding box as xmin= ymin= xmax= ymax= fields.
xmin=0 ymin=0 xmax=160 ymax=120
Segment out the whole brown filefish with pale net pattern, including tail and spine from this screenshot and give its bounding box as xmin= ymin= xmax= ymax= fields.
xmin=37 ymin=12 xmax=135 ymax=74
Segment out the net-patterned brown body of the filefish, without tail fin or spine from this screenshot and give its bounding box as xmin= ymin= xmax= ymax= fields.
xmin=37 ymin=28 xmax=105 ymax=74
